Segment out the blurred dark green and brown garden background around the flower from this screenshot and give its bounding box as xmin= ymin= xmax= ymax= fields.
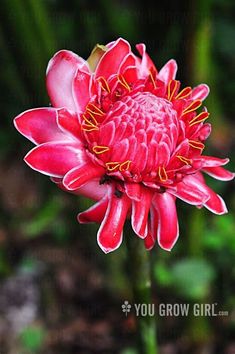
xmin=0 ymin=0 xmax=235 ymax=354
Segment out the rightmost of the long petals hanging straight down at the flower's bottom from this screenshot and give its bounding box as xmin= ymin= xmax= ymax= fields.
xmin=154 ymin=192 xmax=179 ymax=251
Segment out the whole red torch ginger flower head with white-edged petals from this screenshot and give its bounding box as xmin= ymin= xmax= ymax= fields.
xmin=15 ymin=39 xmax=234 ymax=252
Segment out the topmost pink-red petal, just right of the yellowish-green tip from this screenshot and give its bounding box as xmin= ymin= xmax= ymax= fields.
xmin=95 ymin=38 xmax=131 ymax=79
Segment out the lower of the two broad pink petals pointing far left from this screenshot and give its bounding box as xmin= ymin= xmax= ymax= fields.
xmin=25 ymin=142 xmax=83 ymax=177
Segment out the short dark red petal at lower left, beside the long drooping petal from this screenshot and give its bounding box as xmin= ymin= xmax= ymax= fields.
xmin=78 ymin=196 xmax=108 ymax=224
